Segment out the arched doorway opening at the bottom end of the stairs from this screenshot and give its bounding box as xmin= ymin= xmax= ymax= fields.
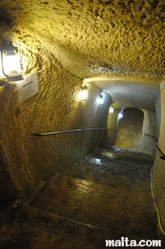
xmin=115 ymin=108 xmax=144 ymax=149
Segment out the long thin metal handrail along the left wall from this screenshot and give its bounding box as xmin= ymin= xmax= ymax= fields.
xmin=31 ymin=128 xmax=117 ymax=137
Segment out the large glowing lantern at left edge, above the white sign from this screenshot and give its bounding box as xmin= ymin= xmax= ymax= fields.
xmin=1 ymin=42 xmax=22 ymax=81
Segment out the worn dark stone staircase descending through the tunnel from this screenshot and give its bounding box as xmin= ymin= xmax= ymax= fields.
xmin=0 ymin=147 xmax=162 ymax=249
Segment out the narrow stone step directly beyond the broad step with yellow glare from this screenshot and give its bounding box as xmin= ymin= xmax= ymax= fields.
xmin=63 ymin=163 xmax=151 ymax=192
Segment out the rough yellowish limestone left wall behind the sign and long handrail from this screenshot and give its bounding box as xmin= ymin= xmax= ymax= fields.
xmin=0 ymin=52 xmax=109 ymax=202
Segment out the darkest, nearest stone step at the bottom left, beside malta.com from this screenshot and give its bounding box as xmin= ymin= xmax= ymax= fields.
xmin=0 ymin=203 xmax=122 ymax=249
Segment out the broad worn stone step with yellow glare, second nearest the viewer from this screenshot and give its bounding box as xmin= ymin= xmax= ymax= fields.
xmin=26 ymin=174 xmax=156 ymax=239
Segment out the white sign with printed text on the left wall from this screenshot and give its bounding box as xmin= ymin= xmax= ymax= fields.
xmin=17 ymin=72 xmax=38 ymax=104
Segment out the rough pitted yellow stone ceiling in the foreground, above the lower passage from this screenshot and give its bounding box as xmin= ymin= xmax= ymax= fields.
xmin=0 ymin=0 xmax=165 ymax=109
